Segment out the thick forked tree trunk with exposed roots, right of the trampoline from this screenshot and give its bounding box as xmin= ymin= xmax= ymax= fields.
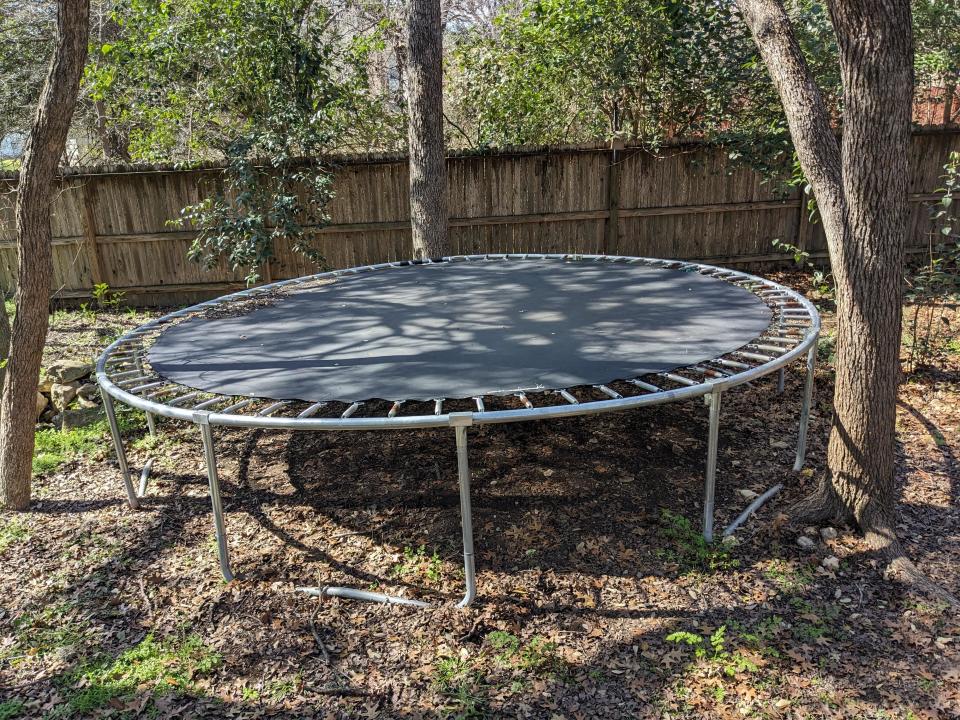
xmin=738 ymin=0 xmax=936 ymax=596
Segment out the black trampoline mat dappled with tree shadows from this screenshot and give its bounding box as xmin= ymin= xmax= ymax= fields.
xmin=149 ymin=260 xmax=771 ymax=402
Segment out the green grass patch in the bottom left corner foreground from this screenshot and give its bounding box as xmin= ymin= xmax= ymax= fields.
xmin=70 ymin=634 xmax=221 ymax=713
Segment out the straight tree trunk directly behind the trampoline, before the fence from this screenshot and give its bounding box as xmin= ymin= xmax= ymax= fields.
xmin=405 ymin=0 xmax=450 ymax=259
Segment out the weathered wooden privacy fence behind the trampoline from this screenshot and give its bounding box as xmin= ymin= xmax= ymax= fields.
xmin=0 ymin=131 xmax=960 ymax=303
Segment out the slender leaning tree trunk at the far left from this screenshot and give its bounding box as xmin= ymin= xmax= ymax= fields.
xmin=0 ymin=0 xmax=90 ymax=510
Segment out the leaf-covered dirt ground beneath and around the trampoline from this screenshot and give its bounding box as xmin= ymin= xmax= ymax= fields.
xmin=0 ymin=276 xmax=960 ymax=720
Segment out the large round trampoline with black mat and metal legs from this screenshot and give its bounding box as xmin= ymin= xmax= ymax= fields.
xmin=97 ymin=254 xmax=820 ymax=606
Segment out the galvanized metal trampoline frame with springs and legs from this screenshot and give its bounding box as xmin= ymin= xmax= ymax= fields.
xmin=96 ymin=253 xmax=820 ymax=607
